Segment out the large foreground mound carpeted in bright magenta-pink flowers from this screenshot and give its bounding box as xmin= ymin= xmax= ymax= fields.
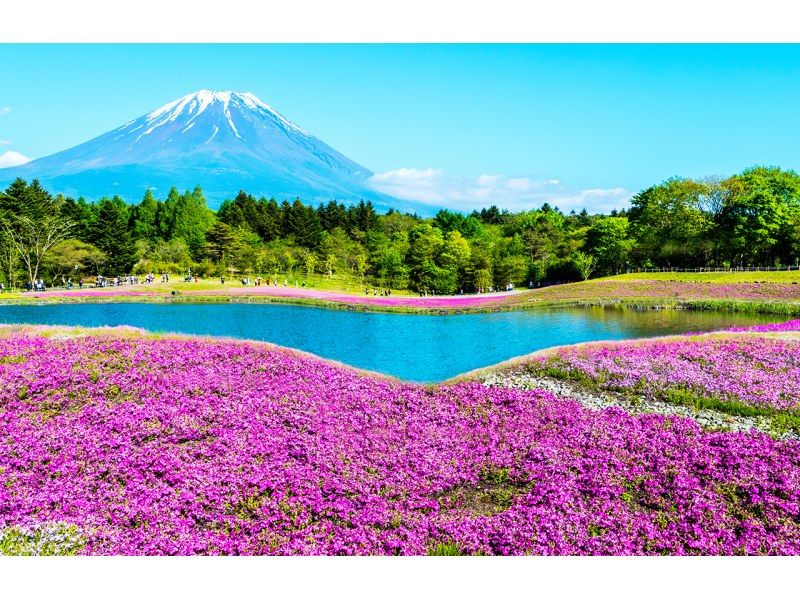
xmin=0 ymin=329 xmax=800 ymax=554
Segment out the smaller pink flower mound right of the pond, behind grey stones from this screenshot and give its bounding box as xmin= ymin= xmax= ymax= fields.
xmin=525 ymin=330 xmax=800 ymax=412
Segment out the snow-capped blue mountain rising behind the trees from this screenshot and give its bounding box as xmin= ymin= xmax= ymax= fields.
xmin=0 ymin=89 xmax=418 ymax=212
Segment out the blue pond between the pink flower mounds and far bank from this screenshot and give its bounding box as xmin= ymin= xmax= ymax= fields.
xmin=0 ymin=303 xmax=780 ymax=382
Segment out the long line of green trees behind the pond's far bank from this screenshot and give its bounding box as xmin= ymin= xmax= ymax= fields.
xmin=0 ymin=167 xmax=800 ymax=294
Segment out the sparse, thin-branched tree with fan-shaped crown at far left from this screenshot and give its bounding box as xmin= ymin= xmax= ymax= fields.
xmin=2 ymin=212 xmax=74 ymax=286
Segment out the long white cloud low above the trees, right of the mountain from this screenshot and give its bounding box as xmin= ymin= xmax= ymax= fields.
xmin=370 ymin=168 xmax=632 ymax=213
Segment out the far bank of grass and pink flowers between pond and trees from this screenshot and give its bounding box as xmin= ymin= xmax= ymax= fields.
xmin=0 ymin=272 xmax=800 ymax=316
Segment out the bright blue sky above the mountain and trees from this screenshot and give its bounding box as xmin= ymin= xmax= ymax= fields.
xmin=0 ymin=44 xmax=800 ymax=211
